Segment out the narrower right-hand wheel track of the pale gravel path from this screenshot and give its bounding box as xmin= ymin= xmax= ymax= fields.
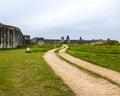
xmin=59 ymin=45 xmax=120 ymax=85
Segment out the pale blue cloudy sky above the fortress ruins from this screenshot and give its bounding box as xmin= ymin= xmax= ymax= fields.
xmin=0 ymin=0 xmax=120 ymax=41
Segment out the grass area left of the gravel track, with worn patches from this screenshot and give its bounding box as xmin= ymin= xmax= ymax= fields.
xmin=0 ymin=45 xmax=75 ymax=96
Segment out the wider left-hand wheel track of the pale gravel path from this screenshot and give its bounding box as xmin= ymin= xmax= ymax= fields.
xmin=43 ymin=50 xmax=120 ymax=96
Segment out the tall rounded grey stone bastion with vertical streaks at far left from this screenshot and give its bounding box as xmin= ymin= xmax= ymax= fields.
xmin=0 ymin=23 xmax=25 ymax=48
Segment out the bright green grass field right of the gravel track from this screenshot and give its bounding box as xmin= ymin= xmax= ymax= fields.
xmin=67 ymin=44 xmax=120 ymax=72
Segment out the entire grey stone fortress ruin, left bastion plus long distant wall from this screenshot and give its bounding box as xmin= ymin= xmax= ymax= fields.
xmin=0 ymin=23 xmax=106 ymax=48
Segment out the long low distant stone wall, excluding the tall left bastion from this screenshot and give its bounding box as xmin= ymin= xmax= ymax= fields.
xmin=31 ymin=37 xmax=106 ymax=45
